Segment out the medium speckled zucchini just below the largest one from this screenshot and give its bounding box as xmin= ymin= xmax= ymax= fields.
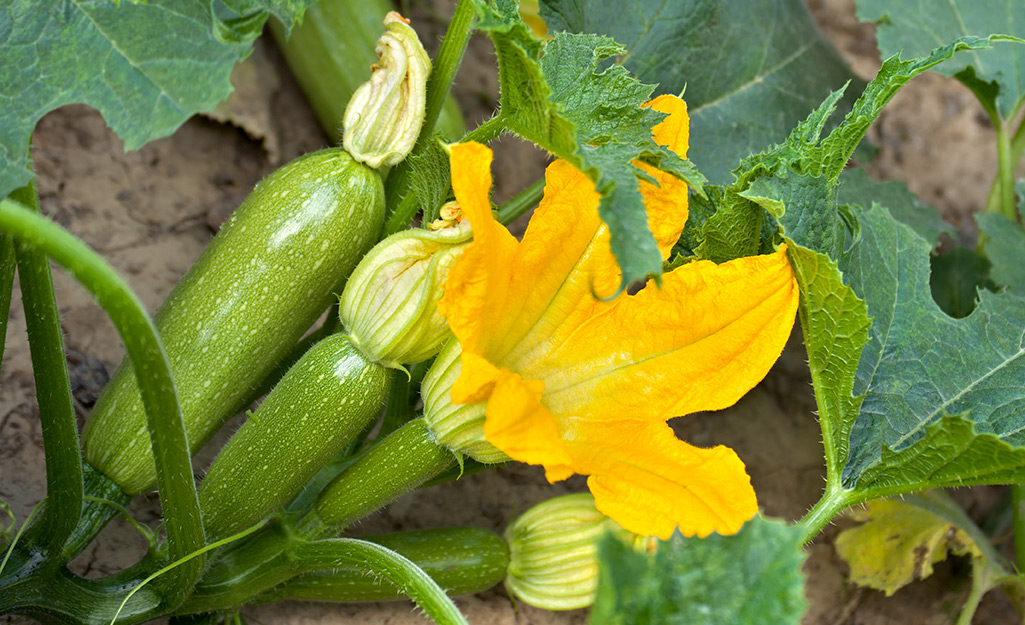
xmin=199 ymin=334 xmax=390 ymax=538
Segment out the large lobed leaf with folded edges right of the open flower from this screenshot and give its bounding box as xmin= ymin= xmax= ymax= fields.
xmin=717 ymin=38 xmax=1025 ymax=500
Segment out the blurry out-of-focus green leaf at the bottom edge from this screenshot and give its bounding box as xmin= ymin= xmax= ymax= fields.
xmin=590 ymin=516 xmax=808 ymax=625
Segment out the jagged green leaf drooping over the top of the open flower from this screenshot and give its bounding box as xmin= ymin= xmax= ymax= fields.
xmin=477 ymin=0 xmax=704 ymax=286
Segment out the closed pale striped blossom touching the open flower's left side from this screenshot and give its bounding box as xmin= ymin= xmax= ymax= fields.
xmin=338 ymin=212 xmax=473 ymax=367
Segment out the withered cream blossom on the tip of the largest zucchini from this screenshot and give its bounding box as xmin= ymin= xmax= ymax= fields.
xmin=342 ymin=11 xmax=431 ymax=169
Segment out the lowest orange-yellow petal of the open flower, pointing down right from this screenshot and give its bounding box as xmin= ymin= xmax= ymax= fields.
xmin=567 ymin=419 xmax=757 ymax=539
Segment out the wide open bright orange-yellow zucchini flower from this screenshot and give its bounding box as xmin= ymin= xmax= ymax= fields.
xmin=439 ymin=96 xmax=797 ymax=538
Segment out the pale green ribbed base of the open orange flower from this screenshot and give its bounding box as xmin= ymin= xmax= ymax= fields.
xmin=420 ymin=338 xmax=509 ymax=464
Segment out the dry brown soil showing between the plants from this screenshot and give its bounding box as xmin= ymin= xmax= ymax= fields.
xmin=0 ymin=0 xmax=1019 ymax=625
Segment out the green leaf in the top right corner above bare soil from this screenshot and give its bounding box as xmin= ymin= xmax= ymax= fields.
xmin=856 ymin=0 xmax=1025 ymax=119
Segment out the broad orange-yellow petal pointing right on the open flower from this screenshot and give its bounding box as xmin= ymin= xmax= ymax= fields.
xmin=537 ymin=247 xmax=798 ymax=421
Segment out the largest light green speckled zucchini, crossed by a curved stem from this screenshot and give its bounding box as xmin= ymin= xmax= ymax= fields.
xmin=84 ymin=149 xmax=384 ymax=495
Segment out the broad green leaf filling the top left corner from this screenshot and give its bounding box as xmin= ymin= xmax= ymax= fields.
xmin=0 ymin=0 xmax=314 ymax=198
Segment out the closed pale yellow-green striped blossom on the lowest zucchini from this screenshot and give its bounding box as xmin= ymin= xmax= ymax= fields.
xmin=505 ymin=493 xmax=632 ymax=610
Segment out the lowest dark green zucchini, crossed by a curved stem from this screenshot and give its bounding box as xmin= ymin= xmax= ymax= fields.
xmin=256 ymin=528 xmax=509 ymax=602
